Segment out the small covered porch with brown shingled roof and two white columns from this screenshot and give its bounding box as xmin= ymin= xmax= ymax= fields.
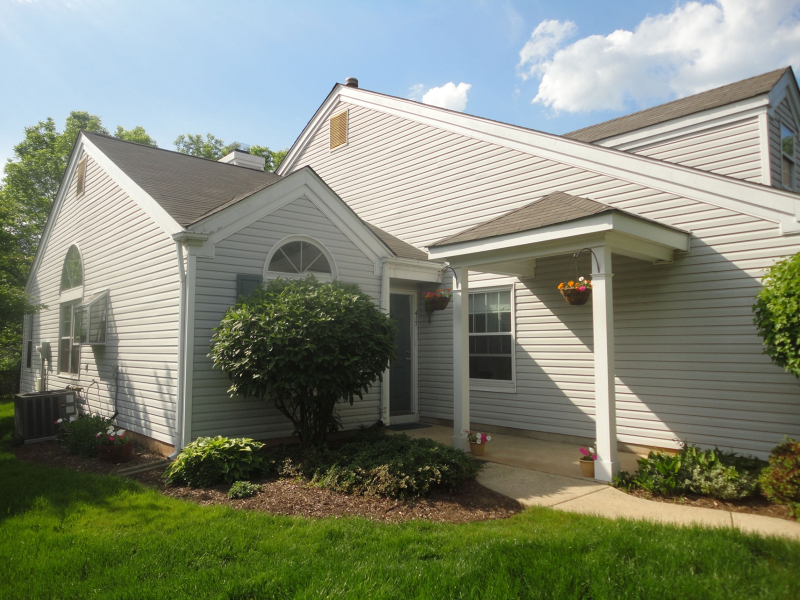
xmin=428 ymin=192 xmax=690 ymax=481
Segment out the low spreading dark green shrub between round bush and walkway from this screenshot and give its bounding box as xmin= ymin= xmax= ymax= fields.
xmin=282 ymin=429 xmax=480 ymax=498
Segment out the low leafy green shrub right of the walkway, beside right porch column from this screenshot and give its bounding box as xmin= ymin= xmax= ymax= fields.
xmin=614 ymin=446 xmax=766 ymax=500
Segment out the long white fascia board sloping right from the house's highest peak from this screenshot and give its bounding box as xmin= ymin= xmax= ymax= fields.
xmin=338 ymin=88 xmax=800 ymax=234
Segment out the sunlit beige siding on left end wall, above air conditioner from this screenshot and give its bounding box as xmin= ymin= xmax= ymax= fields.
xmin=22 ymin=157 xmax=180 ymax=443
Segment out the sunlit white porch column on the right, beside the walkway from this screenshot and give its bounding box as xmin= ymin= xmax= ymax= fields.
xmin=592 ymin=246 xmax=619 ymax=481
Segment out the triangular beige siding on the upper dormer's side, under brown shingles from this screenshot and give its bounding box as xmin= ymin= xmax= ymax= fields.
xmin=620 ymin=116 xmax=762 ymax=183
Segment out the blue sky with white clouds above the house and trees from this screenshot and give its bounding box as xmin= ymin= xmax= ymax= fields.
xmin=0 ymin=0 xmax=800 ymax=163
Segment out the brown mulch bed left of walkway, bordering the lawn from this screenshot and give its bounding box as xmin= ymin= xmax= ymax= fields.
xmin=14 ymin=441 xmax=522 ymax=523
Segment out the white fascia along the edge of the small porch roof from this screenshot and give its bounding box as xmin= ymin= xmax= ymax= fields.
xmin=428 ymin=211 xmax=690 ymax=260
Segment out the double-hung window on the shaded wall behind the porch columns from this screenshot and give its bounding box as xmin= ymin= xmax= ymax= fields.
xmin=469 ymin=288 xmax=515 ymax=384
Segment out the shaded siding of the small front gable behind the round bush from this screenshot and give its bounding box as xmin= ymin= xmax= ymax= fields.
xmin=192 ymin=198 xmax=380 ymax=439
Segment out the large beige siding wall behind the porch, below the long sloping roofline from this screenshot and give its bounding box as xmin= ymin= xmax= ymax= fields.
xmin=296 ymin=98 xmax=800 ymax=455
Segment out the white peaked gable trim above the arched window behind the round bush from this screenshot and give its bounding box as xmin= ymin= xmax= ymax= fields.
xmin=190 ymin=167 xmax=394 ymax=275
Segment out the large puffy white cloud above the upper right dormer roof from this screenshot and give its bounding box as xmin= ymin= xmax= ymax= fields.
xmin=518 ymin=0 xmax=800 ymax=112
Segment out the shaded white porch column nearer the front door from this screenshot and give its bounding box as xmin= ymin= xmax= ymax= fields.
xmin=452 ymin=267 xmax=469 ymax=452
